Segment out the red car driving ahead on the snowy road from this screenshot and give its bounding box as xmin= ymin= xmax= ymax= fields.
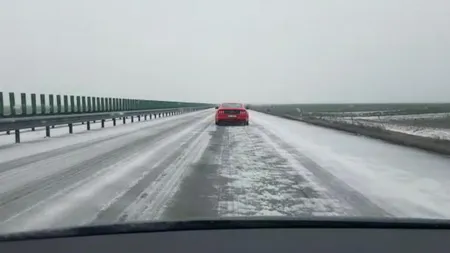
xmin=216 ymin=103 xmax=248 ymax=126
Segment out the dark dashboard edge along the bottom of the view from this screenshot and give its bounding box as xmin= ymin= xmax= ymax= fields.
xmin=0 ymin=217 xmax=450 ymax=253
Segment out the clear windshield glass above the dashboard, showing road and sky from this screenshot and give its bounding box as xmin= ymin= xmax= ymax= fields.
xmin=0 ymin=0 xmax=450 ymax=233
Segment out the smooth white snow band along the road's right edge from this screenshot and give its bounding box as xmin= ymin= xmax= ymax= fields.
xmin=253 ymin=112 xmax=450 ymax=219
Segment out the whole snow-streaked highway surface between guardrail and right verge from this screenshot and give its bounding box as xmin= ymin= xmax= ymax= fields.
xmin=0 ymin=109 xmax=450 ymax=233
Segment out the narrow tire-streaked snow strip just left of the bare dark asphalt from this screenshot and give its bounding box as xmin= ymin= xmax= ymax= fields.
xmin=94 ymin=123 xmax=212 ymax=224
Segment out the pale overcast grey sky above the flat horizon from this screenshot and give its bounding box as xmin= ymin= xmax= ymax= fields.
xmin=0 ymin=0 xmax=450 ymax=103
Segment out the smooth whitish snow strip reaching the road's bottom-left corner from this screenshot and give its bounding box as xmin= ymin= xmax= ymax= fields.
xmin=0 ymin=114 xmax=211 ymax=232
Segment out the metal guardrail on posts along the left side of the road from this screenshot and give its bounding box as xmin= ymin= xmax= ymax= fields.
xmin=0 ymin=106 xmax=211 ymax=143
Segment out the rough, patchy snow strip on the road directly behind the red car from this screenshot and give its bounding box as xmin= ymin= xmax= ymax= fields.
xmin=216 ymin=125 xmax=346 ymax=216
